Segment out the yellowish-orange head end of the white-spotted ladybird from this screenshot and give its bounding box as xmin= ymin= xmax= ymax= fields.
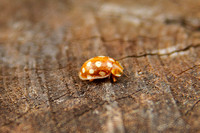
xmin=111 ymin=61 xmax=124 ymax=77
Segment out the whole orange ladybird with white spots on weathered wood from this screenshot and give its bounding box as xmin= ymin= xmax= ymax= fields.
xmin=79 ymin=56 xmax=124 ymax=82
